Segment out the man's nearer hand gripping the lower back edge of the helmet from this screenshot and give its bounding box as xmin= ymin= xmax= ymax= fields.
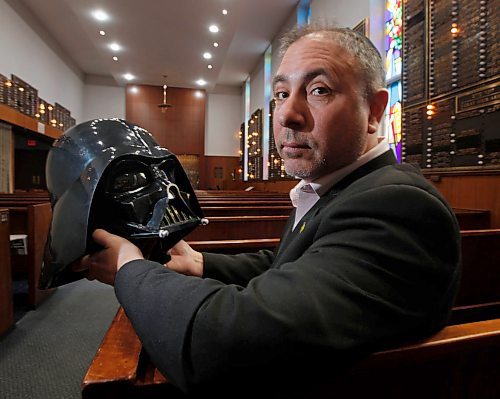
xmin=78 ymin=229 xmax=144 ymax=285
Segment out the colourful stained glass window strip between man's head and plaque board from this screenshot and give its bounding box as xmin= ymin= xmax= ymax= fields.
xmin=385 ymin=0 xmax=403 ymax=161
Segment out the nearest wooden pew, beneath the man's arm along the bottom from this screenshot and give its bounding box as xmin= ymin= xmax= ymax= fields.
xmin=81 ymin=308 xmax=500 ymax=399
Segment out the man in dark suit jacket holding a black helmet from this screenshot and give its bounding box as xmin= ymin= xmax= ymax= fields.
xmin=84 ymin=26 xmax=459 ymax=397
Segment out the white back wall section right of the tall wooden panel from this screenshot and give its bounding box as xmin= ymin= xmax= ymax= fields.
xmin=205 ymin=88 xmax=243 ymax=157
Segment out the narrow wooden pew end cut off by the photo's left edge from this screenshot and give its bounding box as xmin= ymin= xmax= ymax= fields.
xmin=0 ymin=208 xmax=14 ymax=336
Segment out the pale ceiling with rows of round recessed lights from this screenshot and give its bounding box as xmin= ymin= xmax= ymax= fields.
xmin=7 ymin=0 xmax=299 ymax=92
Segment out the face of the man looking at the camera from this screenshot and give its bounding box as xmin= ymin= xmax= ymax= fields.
xmin=273 ymin=37 xmax=376 ymax=181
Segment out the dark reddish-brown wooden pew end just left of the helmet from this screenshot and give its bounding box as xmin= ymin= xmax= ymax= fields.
xmin=8 ymin=202 xmax=53 ymax=307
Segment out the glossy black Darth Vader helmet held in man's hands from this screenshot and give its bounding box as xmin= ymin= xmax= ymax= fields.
xmin=39 ymin=119 xmax=206 ymax=289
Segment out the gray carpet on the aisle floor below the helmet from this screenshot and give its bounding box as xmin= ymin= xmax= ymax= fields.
xmin=0 ymin=279 xmax=118 ymax=399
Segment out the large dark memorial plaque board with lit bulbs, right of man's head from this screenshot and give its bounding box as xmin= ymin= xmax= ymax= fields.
xmin=402 ymin=0 xmax=500 ymax=169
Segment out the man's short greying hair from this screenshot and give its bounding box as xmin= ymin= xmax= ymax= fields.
xmin=280 ymin=22 xmax=385 ymax=98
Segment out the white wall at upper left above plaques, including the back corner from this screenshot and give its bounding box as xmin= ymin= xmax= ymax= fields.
xmin=0 ymin=0 xmax=129 ymax=123
